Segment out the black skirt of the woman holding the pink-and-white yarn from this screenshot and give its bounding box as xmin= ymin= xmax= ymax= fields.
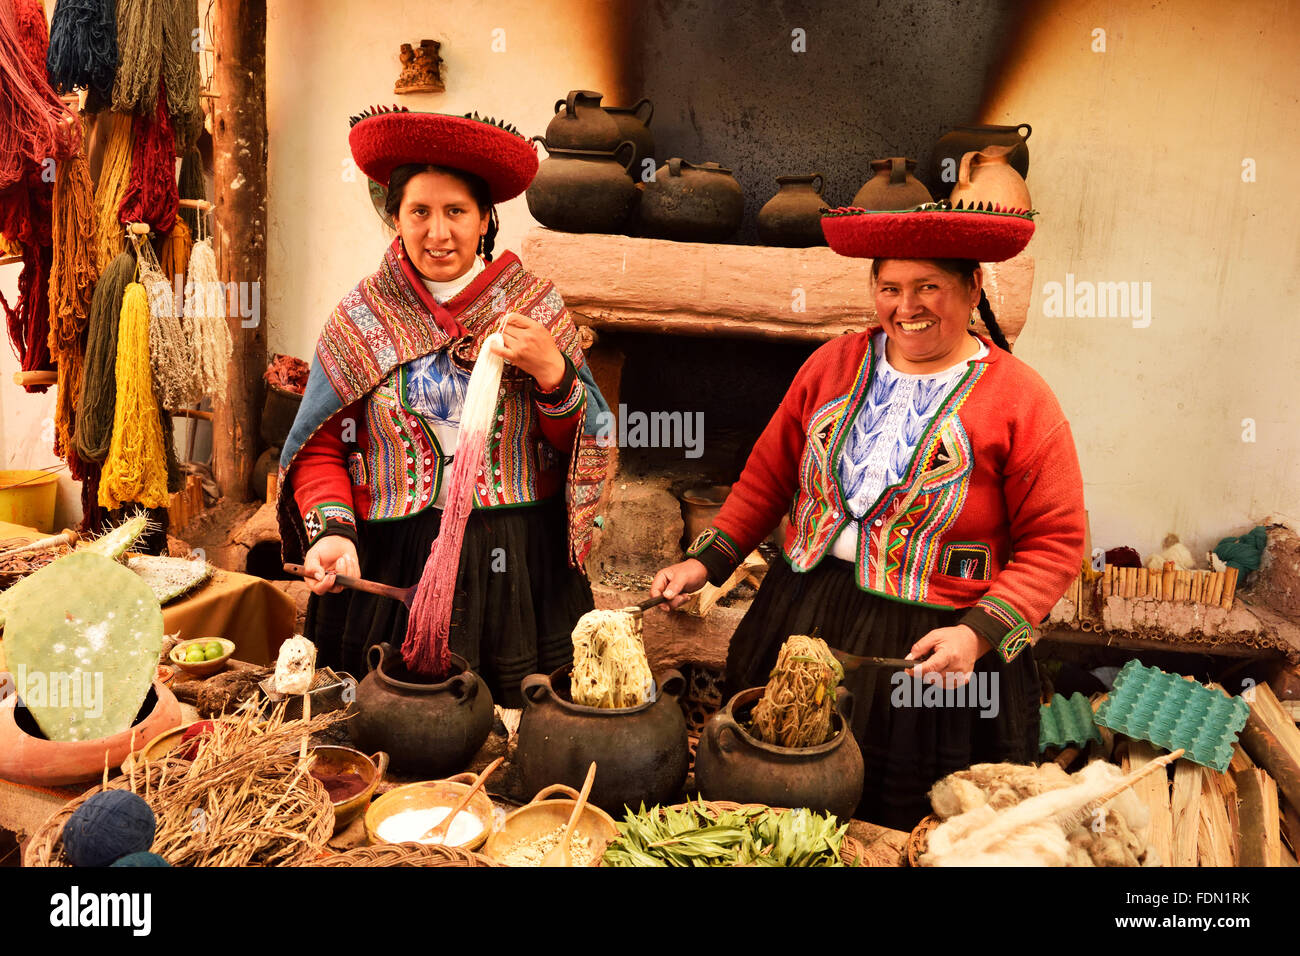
xmin=304 ymin=498 xmax=594 ymax=708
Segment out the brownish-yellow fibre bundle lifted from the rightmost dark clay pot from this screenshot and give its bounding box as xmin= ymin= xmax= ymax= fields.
xmin=753 ymin=633 xmax=844 ymax=747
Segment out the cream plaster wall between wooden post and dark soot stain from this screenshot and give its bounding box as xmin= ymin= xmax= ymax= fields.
xmin=263 ymin=0 xmax=618 ymax=362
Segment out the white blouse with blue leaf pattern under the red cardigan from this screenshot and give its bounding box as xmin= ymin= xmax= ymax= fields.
xmin=831 ymin=332 xmax=988 ymax=562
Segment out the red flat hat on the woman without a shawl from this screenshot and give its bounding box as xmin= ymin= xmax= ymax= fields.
xmin=822 ymin=203 xmax=1035 ymax=263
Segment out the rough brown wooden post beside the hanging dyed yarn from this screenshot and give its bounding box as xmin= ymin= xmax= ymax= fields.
xmin=212 ymin=0 xmax=267 ymax=501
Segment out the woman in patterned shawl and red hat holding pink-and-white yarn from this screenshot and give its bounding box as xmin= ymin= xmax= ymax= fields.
xmin=278 ymin=109 xmax=608 ymax=706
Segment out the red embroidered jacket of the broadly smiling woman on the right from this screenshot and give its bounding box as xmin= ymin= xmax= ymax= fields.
xmin=688 ymin=329 xmax=1084 ymax=661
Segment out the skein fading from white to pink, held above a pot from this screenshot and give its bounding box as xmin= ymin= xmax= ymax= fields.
xmin=402 ymin=332 xmax=504 ymax=678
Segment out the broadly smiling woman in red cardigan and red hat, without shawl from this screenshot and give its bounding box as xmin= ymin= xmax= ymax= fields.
xmin=650 ymin=207 xmax=1084 ymax=829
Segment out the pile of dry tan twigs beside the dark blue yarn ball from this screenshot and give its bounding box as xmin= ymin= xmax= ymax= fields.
xmin=122 ymin=705 xmax=343 ymax=866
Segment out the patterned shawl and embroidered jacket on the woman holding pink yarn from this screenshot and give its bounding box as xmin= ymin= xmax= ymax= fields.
xmin=278 ymin=241 xmax=608 ymax=567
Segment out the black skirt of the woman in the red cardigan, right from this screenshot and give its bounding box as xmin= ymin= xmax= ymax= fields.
xmin=727 ymin=557 xmax=1039 ymax=830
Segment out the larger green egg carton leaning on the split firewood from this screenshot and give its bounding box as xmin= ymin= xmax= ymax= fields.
xmin=1093 ymin=661 xmax=1251 ymax=773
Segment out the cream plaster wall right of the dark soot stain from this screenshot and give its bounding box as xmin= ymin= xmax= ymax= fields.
xmin=984 ymin=0 xmax=1300 ymax=561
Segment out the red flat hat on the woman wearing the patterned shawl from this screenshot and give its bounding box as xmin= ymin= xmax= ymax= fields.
xmin=347 ymin=107 xmax=537 ymax=203
